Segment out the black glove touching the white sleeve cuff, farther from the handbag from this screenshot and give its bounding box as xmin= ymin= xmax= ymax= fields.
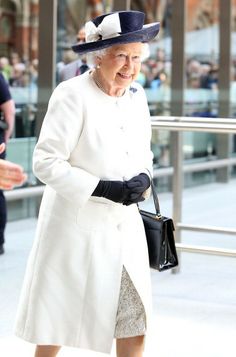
xmin=92 ymin=180 xmax=130 ymax=203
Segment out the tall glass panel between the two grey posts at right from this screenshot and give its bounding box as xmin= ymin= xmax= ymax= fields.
xmin=184 ymin=0 xmax=219 ymax=165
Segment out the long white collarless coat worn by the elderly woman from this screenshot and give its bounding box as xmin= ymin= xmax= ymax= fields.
xmin=15 ymin=72 xmax=152 ymax=353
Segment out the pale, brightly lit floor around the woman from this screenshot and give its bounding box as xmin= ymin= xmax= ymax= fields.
xmin=0 ymin=181 xmax=236 ymax=357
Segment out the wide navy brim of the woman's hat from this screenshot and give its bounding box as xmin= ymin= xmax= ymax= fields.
xmin=72 ymin=22 xmax=160 ymax=54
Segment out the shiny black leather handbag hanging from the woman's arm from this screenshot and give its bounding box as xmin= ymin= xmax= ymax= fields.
xmin=139 ymin=181 xmax=178 ymax=271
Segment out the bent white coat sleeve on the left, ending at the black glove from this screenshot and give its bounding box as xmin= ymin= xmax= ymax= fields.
xmin=33 ymin=82 xmax=99 ymax=207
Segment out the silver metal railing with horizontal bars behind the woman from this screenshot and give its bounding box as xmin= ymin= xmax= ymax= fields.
xmin=6 ymin=116 xmax=236 ymax=257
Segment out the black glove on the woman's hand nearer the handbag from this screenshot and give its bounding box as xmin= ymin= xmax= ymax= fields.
xmin=123 ymin=173 xmax=151 ymax=206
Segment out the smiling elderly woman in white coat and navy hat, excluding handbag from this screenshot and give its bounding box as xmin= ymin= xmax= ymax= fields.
xmin=16 ymin=11 xmax=159 ymax=357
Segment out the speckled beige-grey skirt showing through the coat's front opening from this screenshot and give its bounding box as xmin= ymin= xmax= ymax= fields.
xmin=114 ymin=267 xmax=146 ymax=338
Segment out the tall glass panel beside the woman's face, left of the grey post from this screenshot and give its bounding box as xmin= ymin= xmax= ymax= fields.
xmin=131 ymin=0 xmax=172 ymax=115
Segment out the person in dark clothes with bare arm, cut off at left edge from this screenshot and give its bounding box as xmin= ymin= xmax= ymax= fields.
xmin=0 ymin=73 xmax=15 ymax=254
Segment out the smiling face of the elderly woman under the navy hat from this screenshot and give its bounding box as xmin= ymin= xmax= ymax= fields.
xmin=97 ymin=42 xmax=143 ymax=95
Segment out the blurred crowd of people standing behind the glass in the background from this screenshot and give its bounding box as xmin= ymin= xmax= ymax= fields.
xmin=0 ymin=48 xmax=223 ymax=89
